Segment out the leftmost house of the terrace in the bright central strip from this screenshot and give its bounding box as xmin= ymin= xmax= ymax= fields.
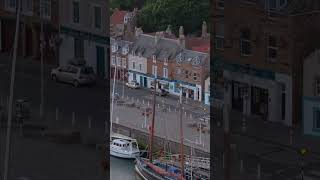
xmin=110 ymin=38 xmax=132 ymax=81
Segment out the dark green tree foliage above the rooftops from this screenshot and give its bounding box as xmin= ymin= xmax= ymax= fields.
xmin=138 ymin=0 xmax=210 ymax=35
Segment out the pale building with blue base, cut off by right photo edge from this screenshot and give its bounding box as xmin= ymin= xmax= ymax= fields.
xmin=302 ymin=50 xmax=320 ymax=136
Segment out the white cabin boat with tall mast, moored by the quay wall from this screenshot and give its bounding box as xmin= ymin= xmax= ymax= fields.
xmin=109 ymin=59 xmax=140 ymax=159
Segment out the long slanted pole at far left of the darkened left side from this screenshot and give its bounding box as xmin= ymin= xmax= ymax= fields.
xmin=3 ymin=0 xmax=21 ymax=180
